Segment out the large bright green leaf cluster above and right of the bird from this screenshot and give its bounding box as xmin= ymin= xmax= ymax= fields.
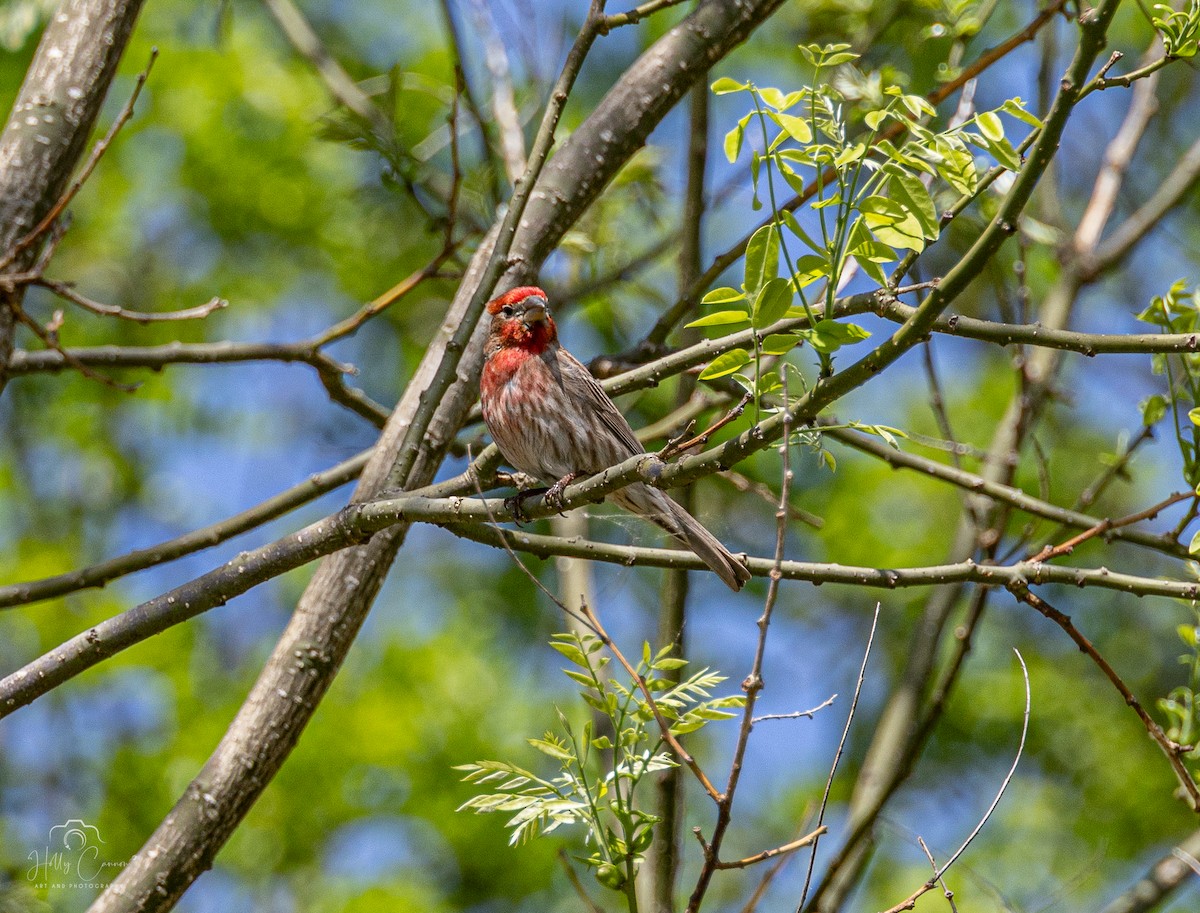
xmin=689 ymin=44 xmax=1040 ymax=395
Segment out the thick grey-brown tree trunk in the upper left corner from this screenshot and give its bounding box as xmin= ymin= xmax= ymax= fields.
xmin=0 ymin=0 xmax=142 ymax=390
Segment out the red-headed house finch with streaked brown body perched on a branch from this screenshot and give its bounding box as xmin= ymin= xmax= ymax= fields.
xmin=480 ymin=287 xmax=750 ymax=590
